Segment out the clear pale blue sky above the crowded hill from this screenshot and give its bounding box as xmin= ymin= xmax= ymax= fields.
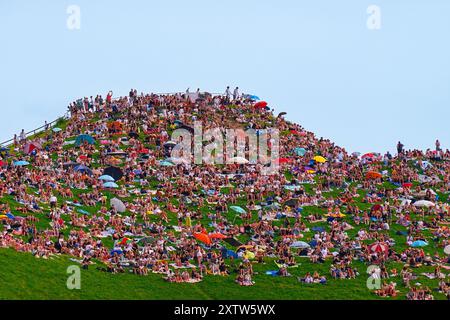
xmin=0 ymin=0 xmax=450 ymax=152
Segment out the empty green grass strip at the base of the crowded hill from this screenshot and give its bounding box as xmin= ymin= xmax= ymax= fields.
xmin=0 ymin=249 xmax=445 ymax=300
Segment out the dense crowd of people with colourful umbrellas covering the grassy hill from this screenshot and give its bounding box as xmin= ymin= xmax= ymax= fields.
xmin=0 ymin=87 xmax=450 ymax=299
